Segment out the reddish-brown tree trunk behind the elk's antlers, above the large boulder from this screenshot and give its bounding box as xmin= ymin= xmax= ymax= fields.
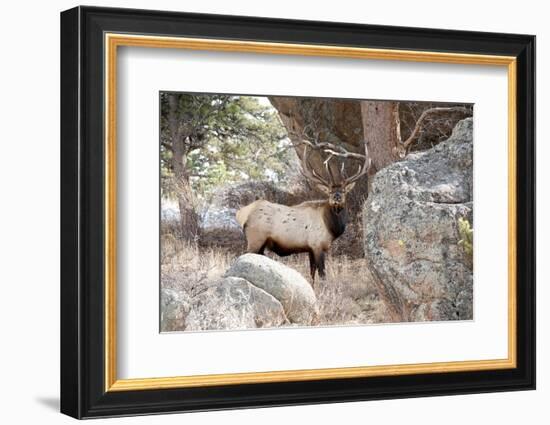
xmin=361 ymin=101 xmax=402 ymax=175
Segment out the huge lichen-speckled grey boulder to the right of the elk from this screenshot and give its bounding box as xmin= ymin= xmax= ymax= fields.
xmin=363 ymin=118 xmax=473 ymax=321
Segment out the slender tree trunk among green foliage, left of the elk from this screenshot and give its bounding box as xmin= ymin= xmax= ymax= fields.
xmin=168 ymin=94 xmax=199 ymax=242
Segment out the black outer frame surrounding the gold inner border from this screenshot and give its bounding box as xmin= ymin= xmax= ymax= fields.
xmin=61 ymin=6 xmax=535 ymax=418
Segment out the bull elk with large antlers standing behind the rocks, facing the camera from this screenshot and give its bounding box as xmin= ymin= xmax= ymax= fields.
xmin=236 ymin=142 xmax=370 ymax=284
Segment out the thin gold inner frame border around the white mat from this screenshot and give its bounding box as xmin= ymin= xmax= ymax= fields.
xmin=104 ymin=33 xmax=517 ymax=391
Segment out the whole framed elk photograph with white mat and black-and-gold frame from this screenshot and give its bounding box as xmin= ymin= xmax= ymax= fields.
xmin=61 ymin=7 xmax=535 ymax=418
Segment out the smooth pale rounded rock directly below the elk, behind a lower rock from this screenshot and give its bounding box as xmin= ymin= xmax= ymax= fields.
xmin=226 ymin=254 xmax=318 ymax=325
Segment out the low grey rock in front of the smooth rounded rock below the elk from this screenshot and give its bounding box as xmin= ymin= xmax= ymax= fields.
xmin=185 ymin=277 xmax=288 ymax=331
